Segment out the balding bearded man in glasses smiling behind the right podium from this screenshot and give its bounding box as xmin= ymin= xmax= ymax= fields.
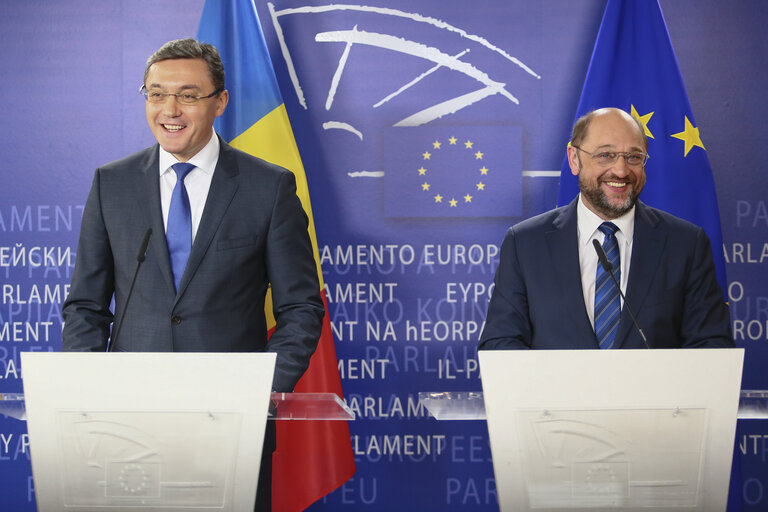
xmin=479 ymin=108 xmax=734 ymax=349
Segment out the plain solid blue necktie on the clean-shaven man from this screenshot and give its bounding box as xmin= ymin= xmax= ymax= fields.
xmin=165 ymin=163 xmax=195 ymax=291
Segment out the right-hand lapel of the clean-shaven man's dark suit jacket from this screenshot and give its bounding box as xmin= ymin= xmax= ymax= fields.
xmin=175 ymin=138 xmax=239 ymax=302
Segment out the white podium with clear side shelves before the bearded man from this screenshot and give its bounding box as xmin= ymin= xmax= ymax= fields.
xmin=420 ymin=349 xmax=744 ymax=512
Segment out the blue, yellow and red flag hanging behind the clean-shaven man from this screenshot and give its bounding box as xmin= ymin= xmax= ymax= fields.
xmin=197 ymin=0 xmax=355 ymax=512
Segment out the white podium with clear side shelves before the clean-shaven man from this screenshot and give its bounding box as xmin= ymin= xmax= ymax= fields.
xmin=0 ymin=352 xmax=354 ymax=512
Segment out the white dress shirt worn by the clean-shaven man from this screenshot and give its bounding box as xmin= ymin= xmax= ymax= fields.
xmin=159 ymin=132 xmax=219 ymax=242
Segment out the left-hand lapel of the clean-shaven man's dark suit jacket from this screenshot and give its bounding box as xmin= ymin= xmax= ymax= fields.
xmin=136 ymin=144 xmax=174 ymax=293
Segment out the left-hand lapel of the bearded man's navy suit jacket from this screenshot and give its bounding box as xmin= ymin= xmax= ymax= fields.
xmin=545 ymin=197 xmax=597 ymax=348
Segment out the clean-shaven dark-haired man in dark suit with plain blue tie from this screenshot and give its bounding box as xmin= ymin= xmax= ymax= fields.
xmin=63 ymin=39 xmax=324 ymax=510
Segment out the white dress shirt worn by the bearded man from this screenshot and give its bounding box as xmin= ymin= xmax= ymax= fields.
xmin=576 ymin=194 xmax=635 ymax=328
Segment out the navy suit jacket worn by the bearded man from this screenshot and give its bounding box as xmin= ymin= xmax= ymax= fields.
xmin=479 ymin=198 xmax=734 ymax=349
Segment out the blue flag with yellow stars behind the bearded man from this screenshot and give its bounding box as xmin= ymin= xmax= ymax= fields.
xmin=557 ymin=0 xmax=727 ymax=293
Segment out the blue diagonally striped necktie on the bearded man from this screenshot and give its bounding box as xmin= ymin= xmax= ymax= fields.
xmin=595 ymin=222 xmax=621 ymax=348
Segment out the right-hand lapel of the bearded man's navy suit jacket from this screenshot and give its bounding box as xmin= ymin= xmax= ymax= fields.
xmin=615 ymin=201 xmax=667 ymax=347
